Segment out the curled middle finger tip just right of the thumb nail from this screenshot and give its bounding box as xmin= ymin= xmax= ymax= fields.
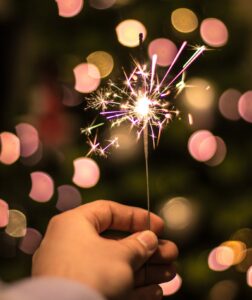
xmin=149 ymin=240 xmax=179 ymax=264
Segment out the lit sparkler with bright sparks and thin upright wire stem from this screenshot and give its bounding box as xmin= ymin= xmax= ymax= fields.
xmin=82 ymin=36 xmax=206 ymax=229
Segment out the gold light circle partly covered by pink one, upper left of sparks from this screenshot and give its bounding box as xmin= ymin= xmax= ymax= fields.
xmin=87 ymin=51 xmax=114 ymax=78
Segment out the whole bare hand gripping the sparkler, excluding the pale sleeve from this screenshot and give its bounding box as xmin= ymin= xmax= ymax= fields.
xmin=32 ymin=200 xmax=178 ymax=300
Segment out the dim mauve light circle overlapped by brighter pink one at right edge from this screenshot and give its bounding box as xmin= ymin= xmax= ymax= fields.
xmin=219 ymin=89 xmax=241 ymax=121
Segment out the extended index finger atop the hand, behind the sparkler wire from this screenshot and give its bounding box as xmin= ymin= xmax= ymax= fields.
xmin=75 ymin=200 xmax=164 ymax=235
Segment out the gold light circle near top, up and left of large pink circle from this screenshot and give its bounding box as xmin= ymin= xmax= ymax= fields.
xmin=171 ymin=7 xmax=198 ymax=33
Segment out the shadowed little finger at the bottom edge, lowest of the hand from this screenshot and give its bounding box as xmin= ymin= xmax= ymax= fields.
xmin=128 ymin=285 xmax=163 ymax=300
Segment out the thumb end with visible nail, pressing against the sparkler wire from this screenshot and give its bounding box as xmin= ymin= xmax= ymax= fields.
xmin=120 ymin=230 xmax=158 ymax=271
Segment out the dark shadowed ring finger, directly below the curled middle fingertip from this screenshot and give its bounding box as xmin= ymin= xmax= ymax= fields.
xmin=135 ymin=264 xmax=176 ymax=287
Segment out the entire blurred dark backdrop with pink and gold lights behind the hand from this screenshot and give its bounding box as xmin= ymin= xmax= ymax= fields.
xmin=0 ymin=0 xmax=252 ymax=300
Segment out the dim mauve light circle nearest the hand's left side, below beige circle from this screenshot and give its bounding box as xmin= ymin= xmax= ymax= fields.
xmin=19 ymin=227 xmax=42 ymax=255
